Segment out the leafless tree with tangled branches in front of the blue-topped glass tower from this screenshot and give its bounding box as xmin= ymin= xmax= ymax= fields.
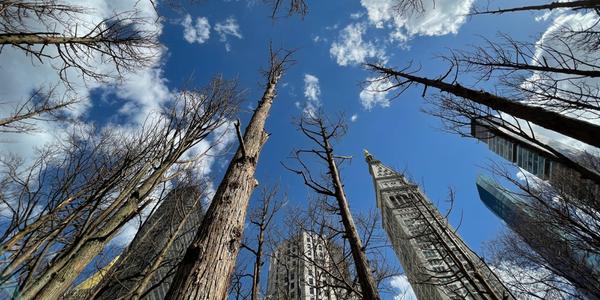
xmin=480 ymin=165 xmax=600 ymax=299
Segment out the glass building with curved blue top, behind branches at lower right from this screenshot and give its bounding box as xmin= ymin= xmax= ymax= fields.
xmin=477 ymin=175 xmax=600 ymax=299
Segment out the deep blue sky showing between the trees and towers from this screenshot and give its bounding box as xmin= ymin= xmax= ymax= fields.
xmin=0 ymin=0 xmax=576 ymax=298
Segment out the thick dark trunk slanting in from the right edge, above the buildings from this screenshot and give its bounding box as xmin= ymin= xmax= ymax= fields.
xmin=369 ymin=65 xmax=600 ymax=148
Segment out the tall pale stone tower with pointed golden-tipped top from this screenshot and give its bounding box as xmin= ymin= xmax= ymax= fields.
xmin=365 ymin=151 xmax=514 ymax=300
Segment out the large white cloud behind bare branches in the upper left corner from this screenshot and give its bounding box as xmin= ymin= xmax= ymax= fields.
xmin=0 ymin=0 xmax=168 ymax=158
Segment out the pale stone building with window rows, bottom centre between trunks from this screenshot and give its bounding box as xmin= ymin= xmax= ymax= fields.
xmin=266 ymin=231 xmax=355 ymax=300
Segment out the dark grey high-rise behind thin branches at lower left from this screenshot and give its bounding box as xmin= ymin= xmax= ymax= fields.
xmin=94 ymin=186 xmax=203 ymax=300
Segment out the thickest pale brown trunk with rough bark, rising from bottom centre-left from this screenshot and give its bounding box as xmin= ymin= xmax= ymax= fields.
xmin=166 ymin=49 xmax=289 ymax=300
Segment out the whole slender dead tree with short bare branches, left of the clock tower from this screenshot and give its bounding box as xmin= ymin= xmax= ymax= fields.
xmin=286 ymin=115 xmax=379 ymax=299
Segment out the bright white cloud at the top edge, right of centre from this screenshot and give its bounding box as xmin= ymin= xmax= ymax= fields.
xmin=360 ymin=0 xmax=474 ymax=42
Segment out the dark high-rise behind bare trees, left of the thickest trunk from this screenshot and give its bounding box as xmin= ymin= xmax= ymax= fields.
xmin=88 ymin=186 xmax=202 ymax=300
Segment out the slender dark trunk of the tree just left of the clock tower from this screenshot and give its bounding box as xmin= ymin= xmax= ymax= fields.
xmin=319 ymin=123 xmax=380 ymax=300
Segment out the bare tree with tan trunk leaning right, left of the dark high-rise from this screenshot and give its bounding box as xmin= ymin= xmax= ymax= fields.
xmin=20 ymin=79 xmax=236 ymax=299
